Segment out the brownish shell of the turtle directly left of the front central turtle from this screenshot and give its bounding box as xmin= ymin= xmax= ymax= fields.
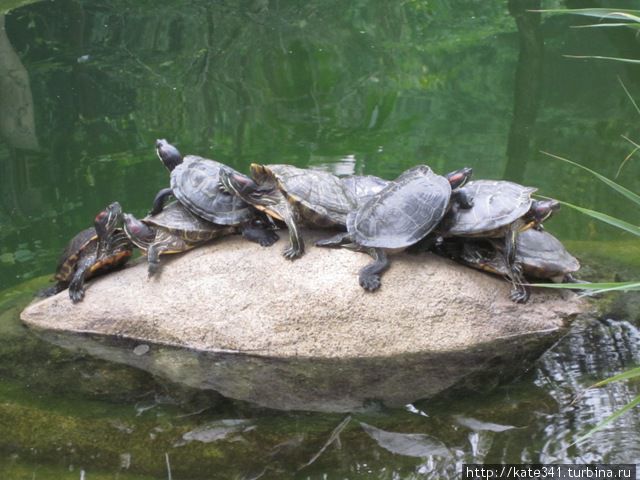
xmin=266 ymin=165 xmax=355 ymax=227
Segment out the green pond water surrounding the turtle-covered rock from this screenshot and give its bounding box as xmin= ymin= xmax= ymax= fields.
xmin=0 ymin=0 xmax=640 ymax=480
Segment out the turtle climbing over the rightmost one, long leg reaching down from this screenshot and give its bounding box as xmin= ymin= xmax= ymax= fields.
xmin=441 ymin=180 xmax=560 ymax=303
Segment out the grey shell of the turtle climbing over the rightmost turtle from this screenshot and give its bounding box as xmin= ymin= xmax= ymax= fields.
xmin=447 ymin=180 xmax=536 ymax=237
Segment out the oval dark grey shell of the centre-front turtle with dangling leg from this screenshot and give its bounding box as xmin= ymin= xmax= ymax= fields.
xmin=347 ymin=165 xmax=451 ymax=249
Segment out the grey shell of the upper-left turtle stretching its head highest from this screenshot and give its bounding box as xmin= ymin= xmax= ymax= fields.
xmin=171 ymin=155 xmax=253 ymax=225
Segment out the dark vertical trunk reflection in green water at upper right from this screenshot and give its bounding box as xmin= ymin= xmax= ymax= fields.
xmin=504 ymin=0 xmax=544 ymax=182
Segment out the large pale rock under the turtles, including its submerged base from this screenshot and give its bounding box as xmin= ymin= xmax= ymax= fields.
xmin=21 ymin=232 xmax=584 ymax=411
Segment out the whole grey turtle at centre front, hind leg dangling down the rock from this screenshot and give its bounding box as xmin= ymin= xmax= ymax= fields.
xmin=316 ymin=165 xmax=473 ymax=291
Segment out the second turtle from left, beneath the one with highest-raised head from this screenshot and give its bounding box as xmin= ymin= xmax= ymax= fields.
xmin=123 ymin=202 xmax=238 ymax=277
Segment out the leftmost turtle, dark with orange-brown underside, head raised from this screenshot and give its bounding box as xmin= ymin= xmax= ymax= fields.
xmin=43 ymin=202 xmax=133 ymax=303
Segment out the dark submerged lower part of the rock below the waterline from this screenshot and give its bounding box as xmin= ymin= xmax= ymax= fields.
xmin=37 ymin=330 xmax=563 ymax=412
